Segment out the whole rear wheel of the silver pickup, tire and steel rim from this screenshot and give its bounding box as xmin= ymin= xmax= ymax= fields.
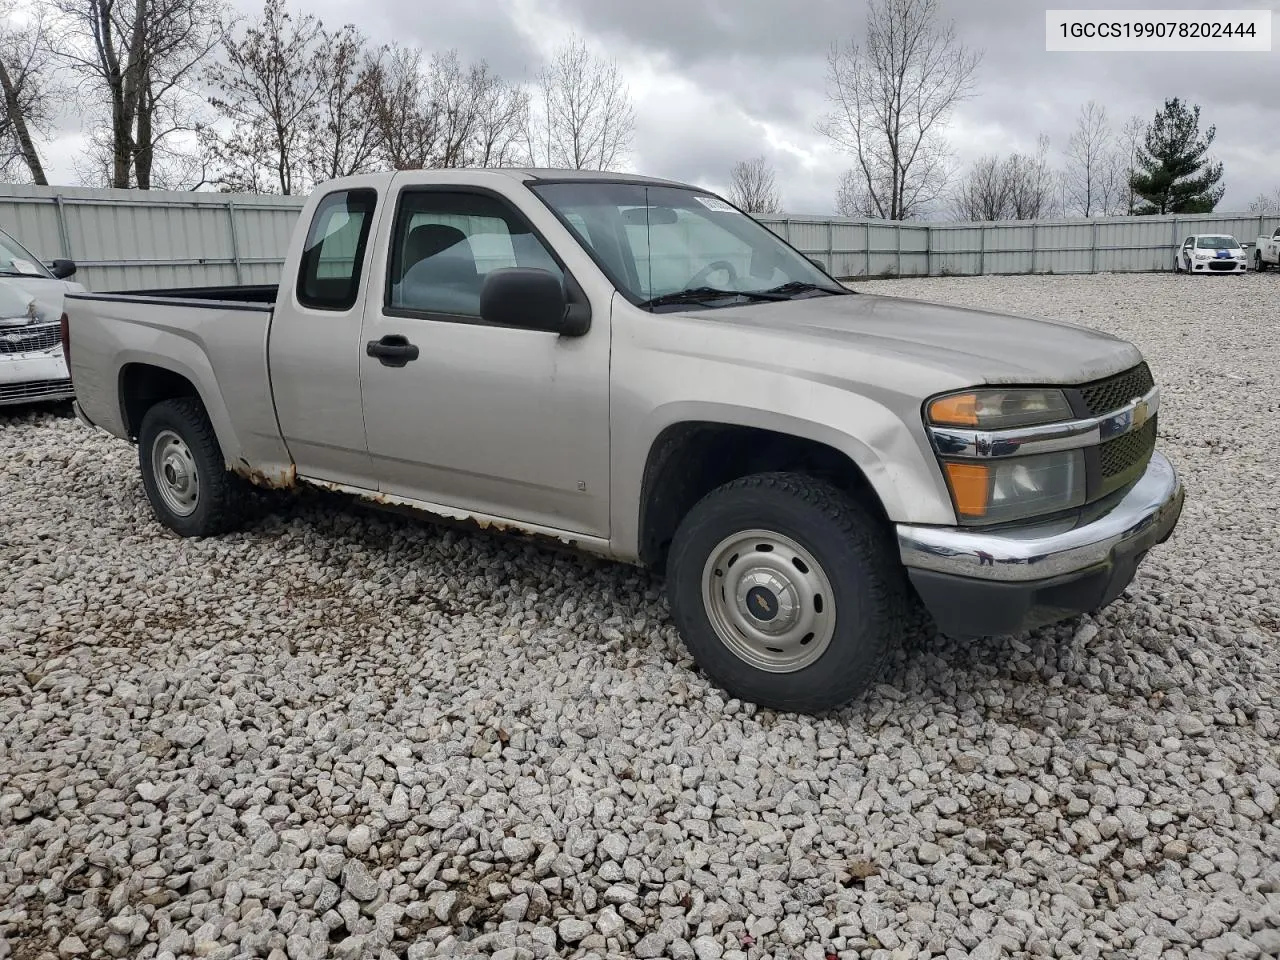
xmin=138 ymin=398 xmax=247 ymax=536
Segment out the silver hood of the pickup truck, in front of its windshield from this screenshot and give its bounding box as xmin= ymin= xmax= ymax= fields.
xmin=706 ymin=293 xmax=1142 ymax=384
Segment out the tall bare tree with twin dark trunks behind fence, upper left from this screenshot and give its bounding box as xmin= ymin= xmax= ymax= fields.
xmin=54 ymin=0 xmax=223 ymax=189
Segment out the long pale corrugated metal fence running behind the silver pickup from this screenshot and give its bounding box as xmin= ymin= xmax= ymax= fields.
xmin=0 ymin=184 xmax=1280 ymax=291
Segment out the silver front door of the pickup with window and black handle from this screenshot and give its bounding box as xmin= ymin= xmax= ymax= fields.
xmin=360 ymin=187 xmax=609 ymax=538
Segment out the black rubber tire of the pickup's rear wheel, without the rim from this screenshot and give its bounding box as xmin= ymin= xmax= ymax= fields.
xmin=138 ymin=398 xmax=248 ymax=536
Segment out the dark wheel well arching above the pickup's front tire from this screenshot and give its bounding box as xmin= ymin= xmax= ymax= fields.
xmin=640 ymin=422 xmax=888 ymax=568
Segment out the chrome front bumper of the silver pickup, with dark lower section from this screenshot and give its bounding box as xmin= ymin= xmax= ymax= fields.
xmin=897 ymin=452 xmax=1184 ymax=636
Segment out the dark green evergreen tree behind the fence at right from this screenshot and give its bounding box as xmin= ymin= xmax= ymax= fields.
xmin=1132 ymin=97 xmax=1226 ymax=214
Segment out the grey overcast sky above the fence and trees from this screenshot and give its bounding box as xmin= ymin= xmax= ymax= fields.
xmin=40 ymin=0 xmax=1280 ymax=214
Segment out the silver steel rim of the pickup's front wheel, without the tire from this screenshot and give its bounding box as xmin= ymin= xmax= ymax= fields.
xmin=703 ymin=530 xmax=836 ymax=673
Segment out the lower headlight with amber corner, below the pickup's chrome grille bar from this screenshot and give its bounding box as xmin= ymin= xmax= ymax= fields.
xmin=942 ymin=451 xmax=1084 ymax=524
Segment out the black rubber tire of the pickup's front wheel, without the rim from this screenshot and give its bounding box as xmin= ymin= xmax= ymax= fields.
xmin=667 ymin=472 xmax=910 ymax=713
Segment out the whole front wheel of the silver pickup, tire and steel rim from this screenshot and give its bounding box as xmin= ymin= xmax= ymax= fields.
xmin=667 ymin=474 xmax=909 ymax=713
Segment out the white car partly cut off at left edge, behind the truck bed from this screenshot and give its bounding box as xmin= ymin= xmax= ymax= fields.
xmin=0 ymin=230 xmax=84 ymax=406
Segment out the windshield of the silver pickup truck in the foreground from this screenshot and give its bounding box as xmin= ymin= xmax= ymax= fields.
xmin=529 ymin=182 xmax=847 ymax=307
